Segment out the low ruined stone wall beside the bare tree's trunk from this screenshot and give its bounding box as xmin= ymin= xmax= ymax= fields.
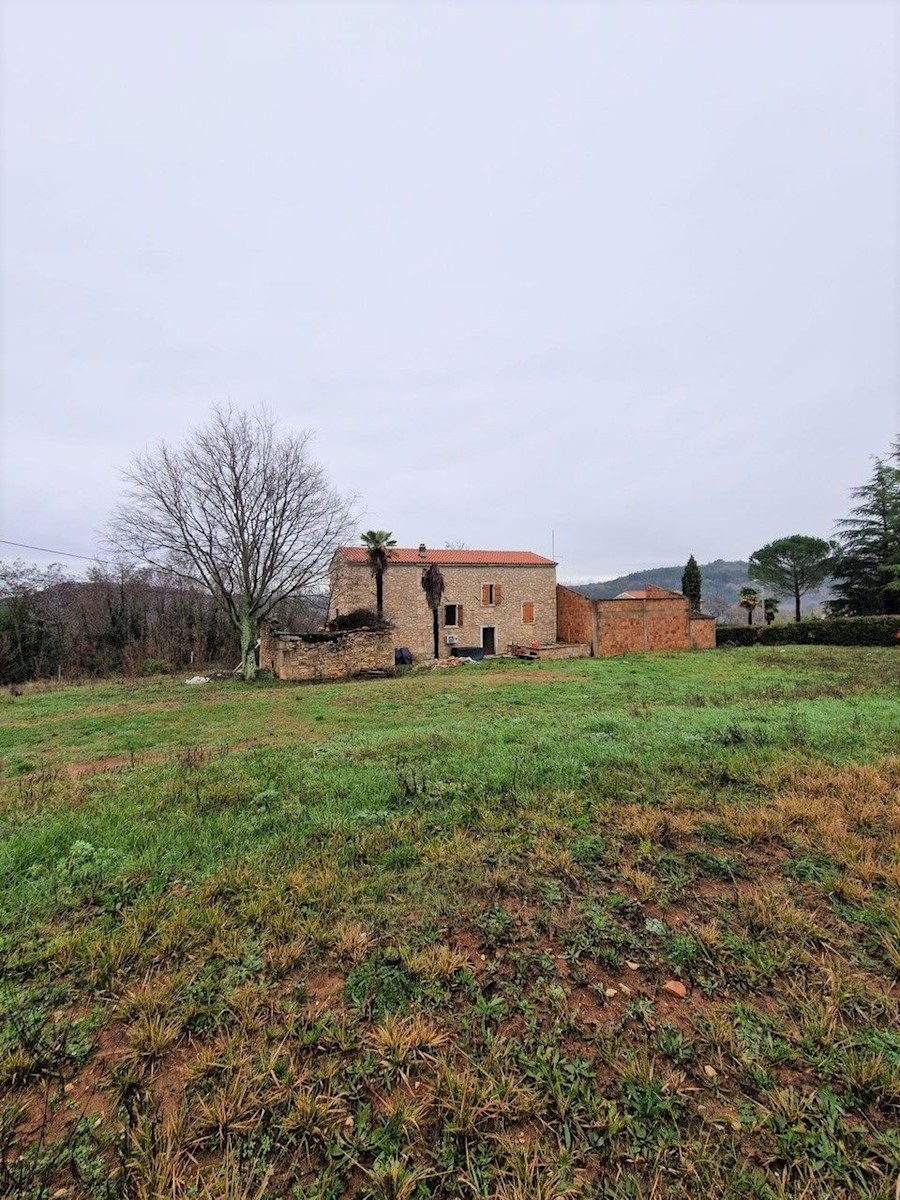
xmin=259 ymin=626 xmax=394 ymax=682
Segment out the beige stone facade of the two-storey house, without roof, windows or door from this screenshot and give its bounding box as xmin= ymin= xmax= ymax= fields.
xmin=329 ymin=560 xmax=557 ymax=661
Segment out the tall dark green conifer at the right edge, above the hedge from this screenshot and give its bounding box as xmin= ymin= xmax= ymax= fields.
xmin=828 ymin=440 xmax=900 ymax=617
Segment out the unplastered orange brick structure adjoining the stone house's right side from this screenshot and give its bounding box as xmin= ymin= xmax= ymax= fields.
xmin=557 ymin=584 xmax=715 ymax=658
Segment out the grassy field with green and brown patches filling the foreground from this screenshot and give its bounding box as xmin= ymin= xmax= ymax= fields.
xmin=0 ymin=647 xmax=900 ymax=1200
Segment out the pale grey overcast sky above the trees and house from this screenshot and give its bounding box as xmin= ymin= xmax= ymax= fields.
xmin=0 ymin=0 xmax=900 ymax=580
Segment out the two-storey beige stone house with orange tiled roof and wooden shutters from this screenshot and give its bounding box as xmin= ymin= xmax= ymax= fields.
xmin=329 ymin=546 xmax=557 ymax=660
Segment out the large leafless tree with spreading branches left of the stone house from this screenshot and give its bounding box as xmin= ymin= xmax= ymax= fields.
xmin=108 ymin=406 xmax=353 ymax=679
